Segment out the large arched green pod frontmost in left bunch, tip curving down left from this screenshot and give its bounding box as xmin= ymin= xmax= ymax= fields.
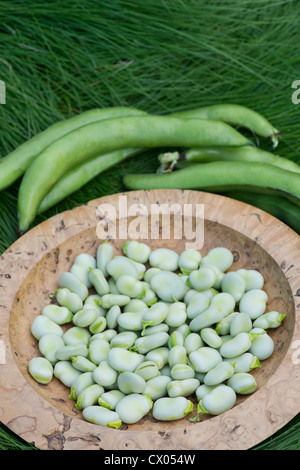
xmin=18 ymin=116 xmax=249 ymax=232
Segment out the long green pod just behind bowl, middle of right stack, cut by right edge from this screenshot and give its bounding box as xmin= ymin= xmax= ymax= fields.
xmin=124 ymin=161 xmax=300 ymax=206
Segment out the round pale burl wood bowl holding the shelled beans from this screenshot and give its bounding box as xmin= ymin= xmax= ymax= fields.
xmin=0 ymin=190 xmax=300 ymax=450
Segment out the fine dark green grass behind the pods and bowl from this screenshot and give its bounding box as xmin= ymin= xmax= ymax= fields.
xmin=0 ymin=0 xmax=300 ymax=450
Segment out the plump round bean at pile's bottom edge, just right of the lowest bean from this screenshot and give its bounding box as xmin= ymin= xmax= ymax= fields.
xmin=116 ymin=393 xmax=153 ymax=424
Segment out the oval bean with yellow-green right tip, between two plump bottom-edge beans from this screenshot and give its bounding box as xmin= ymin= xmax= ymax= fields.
xmin=152 ymin=397 xmax=194 ymax=421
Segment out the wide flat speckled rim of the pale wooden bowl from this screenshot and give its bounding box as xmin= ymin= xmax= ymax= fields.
xmin=0 ymin=189 xmax=300 ymax=450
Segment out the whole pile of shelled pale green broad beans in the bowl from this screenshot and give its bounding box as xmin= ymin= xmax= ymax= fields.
xmin=28 ymin=240 xmax=285 ymax=428
